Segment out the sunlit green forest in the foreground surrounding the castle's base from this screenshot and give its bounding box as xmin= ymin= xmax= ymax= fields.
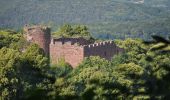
xmin=0 ymin=24 xmax=170 ymax=100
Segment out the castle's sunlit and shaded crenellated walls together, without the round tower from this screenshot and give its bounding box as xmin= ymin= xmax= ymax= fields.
xmin=50 ymin=41 xmax=123 ymax=68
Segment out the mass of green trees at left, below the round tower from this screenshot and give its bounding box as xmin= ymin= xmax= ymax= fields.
xmin=0 ymin=31 xmax=51 ymax=100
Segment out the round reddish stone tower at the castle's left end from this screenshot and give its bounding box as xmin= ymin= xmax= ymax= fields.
xmin=24 ymin=25 xmax=51 ymax=56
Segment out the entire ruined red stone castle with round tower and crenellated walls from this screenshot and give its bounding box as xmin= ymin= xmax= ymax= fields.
xmin=24 ymin=26 xmax=123 ymax=68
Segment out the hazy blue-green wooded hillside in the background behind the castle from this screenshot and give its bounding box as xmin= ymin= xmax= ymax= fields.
xmin=0 ymin=0 xmax=170 ymax=38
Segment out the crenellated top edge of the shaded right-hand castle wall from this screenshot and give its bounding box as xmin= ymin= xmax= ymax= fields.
xmin=84 ymin=41 xmax=114 ymax=48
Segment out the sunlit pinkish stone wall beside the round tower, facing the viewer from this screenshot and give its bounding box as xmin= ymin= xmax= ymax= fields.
xmin=50 ymin=39 xmax=84 ymax=68
